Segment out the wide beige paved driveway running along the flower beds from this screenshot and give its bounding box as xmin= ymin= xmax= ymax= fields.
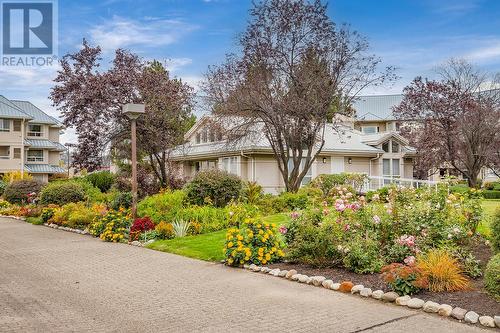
xmin=0 ymin=218 xmax=485 ymax=333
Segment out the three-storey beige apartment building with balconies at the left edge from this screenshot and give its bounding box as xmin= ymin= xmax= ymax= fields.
xmin=0 ymin=95 xmax=66 ymax=182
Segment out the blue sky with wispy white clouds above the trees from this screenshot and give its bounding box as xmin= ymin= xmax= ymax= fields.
xmin=0 ymin=0 xmax=500 ymax=143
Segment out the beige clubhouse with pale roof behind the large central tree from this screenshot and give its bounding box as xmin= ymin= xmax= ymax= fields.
xmin=171 ymin=93 xmax=416 ymax=193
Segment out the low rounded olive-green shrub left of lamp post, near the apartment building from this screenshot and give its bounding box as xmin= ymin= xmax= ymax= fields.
xmin=40 ymin=181 xmax=85 ymax=206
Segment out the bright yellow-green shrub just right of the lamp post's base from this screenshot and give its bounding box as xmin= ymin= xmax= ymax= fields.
xmin=137 ymin=190 xmax=186 ymax=224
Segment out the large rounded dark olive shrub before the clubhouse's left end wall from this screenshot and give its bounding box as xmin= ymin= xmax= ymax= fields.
xmin=185 ymin=169 xmax=243 ymax=207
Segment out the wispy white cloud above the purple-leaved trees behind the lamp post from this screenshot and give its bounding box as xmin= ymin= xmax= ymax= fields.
xmin=90 ymin=15 xmax=196 ymax=52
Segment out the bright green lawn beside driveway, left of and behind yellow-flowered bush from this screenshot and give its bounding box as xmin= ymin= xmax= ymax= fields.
xmin=147 ymin=214 xmax=289 ymax=261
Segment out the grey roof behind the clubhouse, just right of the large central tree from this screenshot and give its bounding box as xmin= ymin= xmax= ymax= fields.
xmin=353 ymin=95 xmax=403 ymax=121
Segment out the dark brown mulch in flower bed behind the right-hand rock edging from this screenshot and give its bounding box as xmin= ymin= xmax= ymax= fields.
xmin=268 ymin=243 xmax=500 ymax=317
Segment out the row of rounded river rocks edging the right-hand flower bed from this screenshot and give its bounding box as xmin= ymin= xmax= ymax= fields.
xmin=243 ymin=264 xmax=500 ymax=328
